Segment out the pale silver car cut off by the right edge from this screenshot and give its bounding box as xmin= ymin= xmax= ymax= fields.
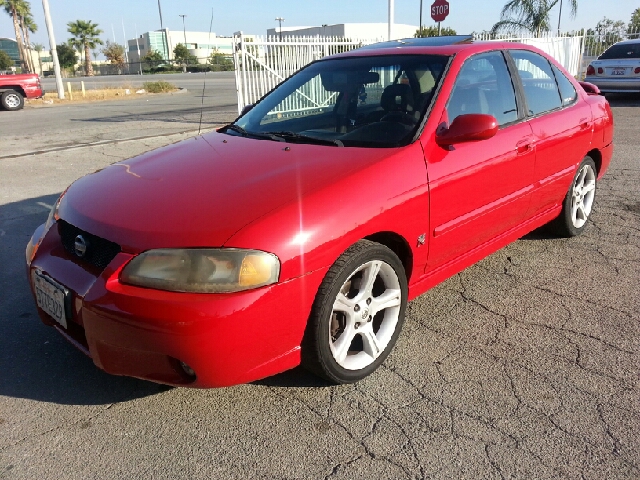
xmin=585 ymin=38 xmax=640 ymax=93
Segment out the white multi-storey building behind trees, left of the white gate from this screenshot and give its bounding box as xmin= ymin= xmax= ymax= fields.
xmin=127 ymin=28 xmax=252 ymax=63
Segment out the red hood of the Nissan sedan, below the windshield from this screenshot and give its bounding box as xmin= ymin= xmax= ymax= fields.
xmin=59 ymin=132 xmax=395 ymax=253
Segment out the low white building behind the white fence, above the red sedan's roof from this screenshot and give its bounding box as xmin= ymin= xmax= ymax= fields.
xmin=267 ymin=23 xmax=418 ymax=40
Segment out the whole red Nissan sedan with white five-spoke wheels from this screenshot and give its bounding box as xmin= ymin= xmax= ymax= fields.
xmin=26 ymin=37 xmax=613 ymax=387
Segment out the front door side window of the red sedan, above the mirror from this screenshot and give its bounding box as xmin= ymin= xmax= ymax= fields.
xmin=447 ymin=52 xmax=518 ymax=126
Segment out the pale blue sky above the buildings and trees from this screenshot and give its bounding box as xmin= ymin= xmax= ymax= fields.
xmin=0 ymin=0 xmax=640 ymax=52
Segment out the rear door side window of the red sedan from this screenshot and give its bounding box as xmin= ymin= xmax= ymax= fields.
xmin=510 ymin=50 xmax=562 ymax=115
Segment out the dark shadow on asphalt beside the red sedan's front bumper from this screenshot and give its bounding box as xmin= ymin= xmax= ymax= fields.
xmin=0 ymin=195 xmax=166 ymax=405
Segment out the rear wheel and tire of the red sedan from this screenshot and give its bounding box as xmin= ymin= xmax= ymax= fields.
xmin=550 ymin=157 xmax=598 ymax=237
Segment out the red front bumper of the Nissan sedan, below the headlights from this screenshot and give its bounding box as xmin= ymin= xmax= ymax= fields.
xmin=28 ymin=225 xmax=326 ymax=388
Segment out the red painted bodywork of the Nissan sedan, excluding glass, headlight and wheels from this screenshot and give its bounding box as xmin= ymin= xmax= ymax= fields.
xmin=28 ymin=43 xmax=613 ymax=387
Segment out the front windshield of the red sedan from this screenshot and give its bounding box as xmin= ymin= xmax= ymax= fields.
xmin=230 ymin=55 xmax=449 ymax=147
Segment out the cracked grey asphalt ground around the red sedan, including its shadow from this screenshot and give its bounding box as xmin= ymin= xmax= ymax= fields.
xmin=0 ymin=92 xmax=640 ymax=480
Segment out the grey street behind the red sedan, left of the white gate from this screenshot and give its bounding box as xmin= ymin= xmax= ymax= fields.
xmin=0 ymin=72 xmax=238 ymax=159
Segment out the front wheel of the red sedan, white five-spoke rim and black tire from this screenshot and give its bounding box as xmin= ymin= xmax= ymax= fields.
xmin=302 ymin=240 xmax=407 ymax=383
